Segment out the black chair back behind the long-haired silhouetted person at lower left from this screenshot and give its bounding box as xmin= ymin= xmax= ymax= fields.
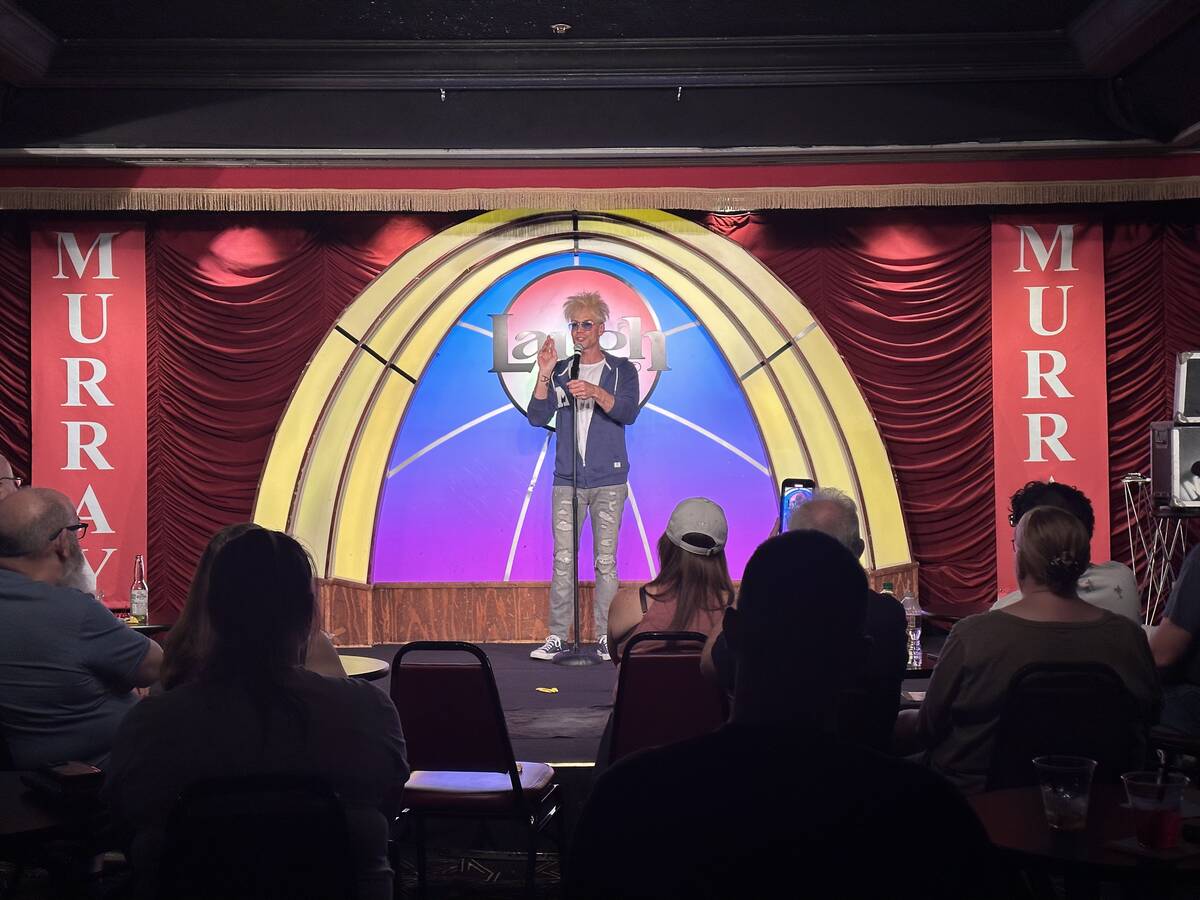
xmin=158 ymin=775 xmax=356 ymax=900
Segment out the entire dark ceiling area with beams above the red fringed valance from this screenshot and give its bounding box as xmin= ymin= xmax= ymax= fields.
xmin=0 ymin=0 xmax=1200 ymax=163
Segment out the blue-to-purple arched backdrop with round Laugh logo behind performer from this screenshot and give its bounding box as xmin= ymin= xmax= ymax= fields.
xmin=371 ymin=253 xmax=778 ymax=582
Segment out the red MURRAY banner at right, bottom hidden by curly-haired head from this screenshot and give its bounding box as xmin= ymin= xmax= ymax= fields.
xmin=991 ymin=216 xmax=1110 ymax=595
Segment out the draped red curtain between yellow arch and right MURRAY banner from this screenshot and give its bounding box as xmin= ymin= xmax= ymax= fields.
xmin=706 ymin=210 xmax=996 ymax=614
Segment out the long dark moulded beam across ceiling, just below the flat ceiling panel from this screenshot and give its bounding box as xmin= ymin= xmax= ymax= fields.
xmin=44 ymin=31 xmax=1090 ymax=90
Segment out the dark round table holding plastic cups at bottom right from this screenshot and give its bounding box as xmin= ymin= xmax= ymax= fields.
xmin=967 ymin=785 xmax=1200 ymax=884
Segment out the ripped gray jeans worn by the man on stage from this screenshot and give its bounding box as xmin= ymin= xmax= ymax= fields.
xmin=550 ymin=485 xmax=629 ymax=641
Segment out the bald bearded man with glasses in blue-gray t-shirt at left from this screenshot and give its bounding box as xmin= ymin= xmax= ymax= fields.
xmin=0 ymin=487 xmax=162 ymax=769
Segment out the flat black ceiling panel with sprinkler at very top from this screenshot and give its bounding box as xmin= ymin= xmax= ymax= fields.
xmin=20 ymin=0 xmax=1088 ymax=41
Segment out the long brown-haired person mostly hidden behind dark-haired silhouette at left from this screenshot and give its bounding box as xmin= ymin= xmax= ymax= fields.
xmin=160 ymin=522 xmax=346 ymax=691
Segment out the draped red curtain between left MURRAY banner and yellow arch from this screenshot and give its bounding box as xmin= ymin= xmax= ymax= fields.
xmin=146 ymin=215 xmax=455 ymax=618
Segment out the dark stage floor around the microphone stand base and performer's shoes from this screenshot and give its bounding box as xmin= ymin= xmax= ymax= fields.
xmin=342 ymin=643 xmax=617 ymax=764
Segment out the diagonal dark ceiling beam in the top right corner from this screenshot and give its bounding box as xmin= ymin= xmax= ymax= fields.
xmin=1067 ymin=0 xmax=1200 ymax=76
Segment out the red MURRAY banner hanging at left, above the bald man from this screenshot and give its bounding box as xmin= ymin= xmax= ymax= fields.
xmin=30 ymin=222 xmax=152 ymax=607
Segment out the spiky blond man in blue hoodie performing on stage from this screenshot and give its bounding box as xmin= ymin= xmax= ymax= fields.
xmin=528 ymin=292 xmax=638 ymax=659
